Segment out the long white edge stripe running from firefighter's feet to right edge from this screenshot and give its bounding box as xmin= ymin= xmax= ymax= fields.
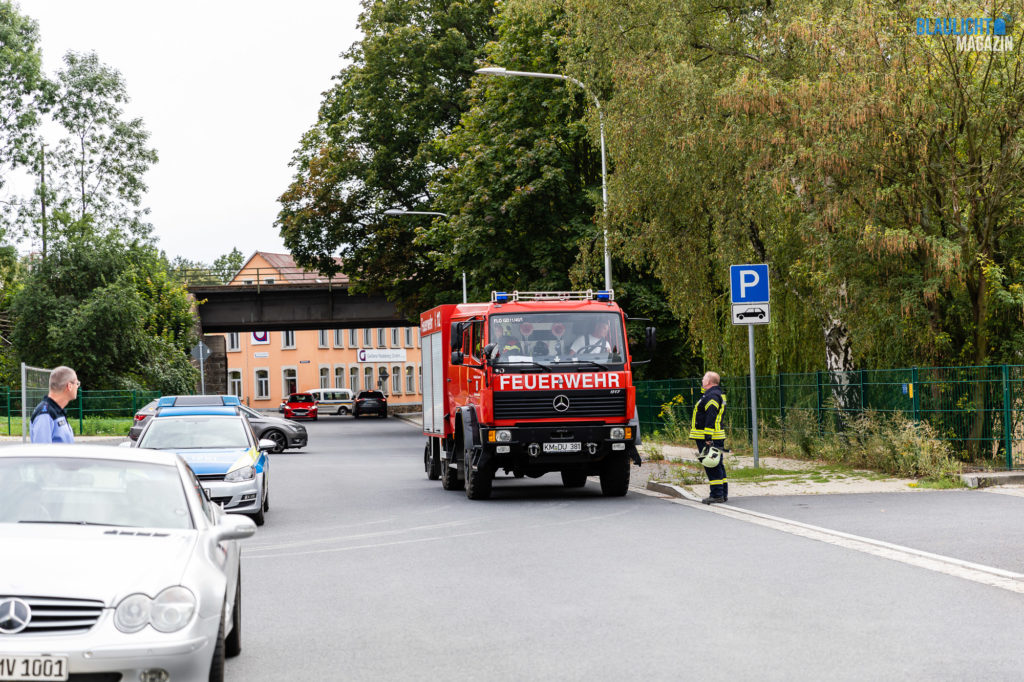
xmin=630 ymin=485 xmax=1024 ymax=594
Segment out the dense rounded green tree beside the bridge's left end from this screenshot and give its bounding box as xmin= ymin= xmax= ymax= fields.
xmin=11 ymin=230 xmax=198 ymax=392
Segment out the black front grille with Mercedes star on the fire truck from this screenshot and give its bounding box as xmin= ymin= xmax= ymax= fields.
xmin=495 ymin=389 xmax=626 ymax=419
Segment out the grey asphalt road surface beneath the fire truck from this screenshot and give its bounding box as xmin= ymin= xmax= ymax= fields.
xmin=227 ymin=418 xmax=1024 ymax=681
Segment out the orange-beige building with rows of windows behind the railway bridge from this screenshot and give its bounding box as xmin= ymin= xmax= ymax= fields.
xmin=222 ymin=251 xmax=423 ymax=410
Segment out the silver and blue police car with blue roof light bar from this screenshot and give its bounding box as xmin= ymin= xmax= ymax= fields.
xmin=135 ymin=395 xmax=276 ymax=525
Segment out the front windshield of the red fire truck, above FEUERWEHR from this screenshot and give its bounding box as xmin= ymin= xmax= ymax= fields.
xmin=488 ymin=312 xmax=626 ymax=371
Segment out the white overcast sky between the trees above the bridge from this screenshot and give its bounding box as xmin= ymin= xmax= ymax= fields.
xmin=15 ymin=0 xmax=360 ymax=262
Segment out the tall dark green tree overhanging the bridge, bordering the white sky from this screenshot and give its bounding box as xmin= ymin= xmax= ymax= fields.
xmin=278 ymin=0 xmax=494 ymax=314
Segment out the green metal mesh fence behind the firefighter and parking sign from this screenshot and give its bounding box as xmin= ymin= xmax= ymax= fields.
xmin=637 ymin=365 xmax=1024 ymax=469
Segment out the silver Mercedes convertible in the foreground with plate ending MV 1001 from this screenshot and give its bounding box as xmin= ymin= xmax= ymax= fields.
xmin=0 ymin=445 xmax=256 ymax=682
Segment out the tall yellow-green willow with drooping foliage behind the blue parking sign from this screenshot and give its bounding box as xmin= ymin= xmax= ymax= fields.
xmin=570 ymin=0 xmax=1024 ymax=387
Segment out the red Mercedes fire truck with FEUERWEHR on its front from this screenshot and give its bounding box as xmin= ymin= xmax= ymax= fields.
xmin=420 ymin=291 xmax=654 ymax=500
